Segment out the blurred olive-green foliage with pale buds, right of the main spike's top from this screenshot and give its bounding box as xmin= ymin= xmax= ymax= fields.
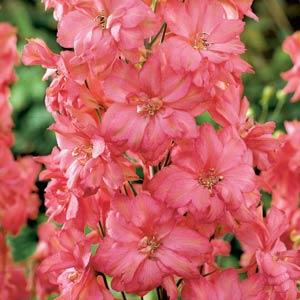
xmin=242 ymin=0 xmax=300 ymax=130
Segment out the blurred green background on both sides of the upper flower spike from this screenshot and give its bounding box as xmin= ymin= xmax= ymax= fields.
xmin=0 ymin=0 xmax=300 ymax=155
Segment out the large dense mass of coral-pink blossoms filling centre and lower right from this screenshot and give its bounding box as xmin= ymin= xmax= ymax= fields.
xmin=23 ymin=0 xmax=300 ymax=300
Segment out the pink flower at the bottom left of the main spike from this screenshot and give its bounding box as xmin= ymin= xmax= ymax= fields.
xmin=39 ymin=227 xmax=113 ymax=300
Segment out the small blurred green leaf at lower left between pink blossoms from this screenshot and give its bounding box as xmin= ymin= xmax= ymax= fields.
xmin=7 ymin=227 xmax=38 ymax=262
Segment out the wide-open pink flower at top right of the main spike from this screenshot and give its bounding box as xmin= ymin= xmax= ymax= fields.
xmin=164 ymin=0 xmax=245 ymax=71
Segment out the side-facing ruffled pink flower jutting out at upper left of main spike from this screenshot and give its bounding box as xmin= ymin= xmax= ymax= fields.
xmin=22 ymin=39 xmax=106 ymax=115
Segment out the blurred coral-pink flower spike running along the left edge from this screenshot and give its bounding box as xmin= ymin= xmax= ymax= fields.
xmin=0 ymin=23 xmax=39 ymax=299
